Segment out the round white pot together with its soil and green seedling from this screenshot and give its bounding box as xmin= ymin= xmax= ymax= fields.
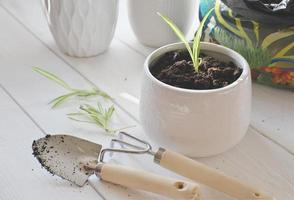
xmin=140 ymin=11 xmax=251 ymax=157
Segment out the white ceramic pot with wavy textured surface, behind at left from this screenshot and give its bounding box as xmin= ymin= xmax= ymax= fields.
xmin=44 ymin=0 xmax=118 ymax=57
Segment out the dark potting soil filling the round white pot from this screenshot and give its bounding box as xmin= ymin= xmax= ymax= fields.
xmin=150 ymin=50 xmax=243 ymax=90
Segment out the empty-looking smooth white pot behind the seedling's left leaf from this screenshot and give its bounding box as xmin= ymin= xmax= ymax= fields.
xmin=128 ymin=0 xmax=199 ymax=47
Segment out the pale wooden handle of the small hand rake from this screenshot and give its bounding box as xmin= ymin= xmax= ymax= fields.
xmin=155 ymin=149 xmax=274 ymax=200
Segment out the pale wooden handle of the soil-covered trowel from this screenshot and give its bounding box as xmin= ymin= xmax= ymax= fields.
xmin=99 ymin=164 xmax=200 ymax=200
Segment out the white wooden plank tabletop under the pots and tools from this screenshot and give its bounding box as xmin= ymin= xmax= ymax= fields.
xmin=0 ymin=0 xmax=294 ymax=200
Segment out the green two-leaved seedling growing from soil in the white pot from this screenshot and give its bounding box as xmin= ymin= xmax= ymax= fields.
xmin=157 ymin=9 xmax=214 ymax=72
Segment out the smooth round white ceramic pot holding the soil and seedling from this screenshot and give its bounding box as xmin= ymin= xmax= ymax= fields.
xmin=140 ymin=43 xmax=251 ymax=157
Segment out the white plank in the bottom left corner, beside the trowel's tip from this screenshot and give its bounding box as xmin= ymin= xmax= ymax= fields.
xmin=0 ymin=88 xmax=101 ymax=200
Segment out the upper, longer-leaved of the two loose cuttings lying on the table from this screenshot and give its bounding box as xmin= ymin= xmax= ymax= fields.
xmin=33 ymin=67 xmax=111 ymax=108
